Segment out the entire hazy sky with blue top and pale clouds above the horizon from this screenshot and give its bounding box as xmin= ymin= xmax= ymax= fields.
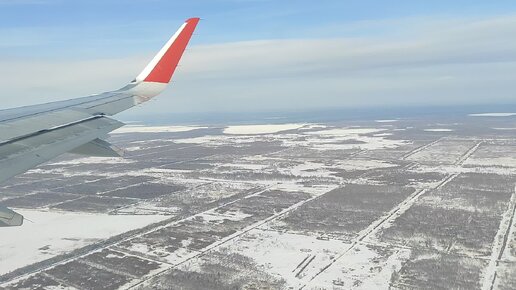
xmin=0 ymin=0 xmax=516 ymax=116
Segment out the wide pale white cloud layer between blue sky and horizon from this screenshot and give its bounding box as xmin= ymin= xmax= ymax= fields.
xmin=0 ymin=15 xmax=516 ymax=113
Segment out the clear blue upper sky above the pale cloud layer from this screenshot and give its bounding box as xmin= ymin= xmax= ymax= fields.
xmin=4 ymin=0 xmax=516 ymax=48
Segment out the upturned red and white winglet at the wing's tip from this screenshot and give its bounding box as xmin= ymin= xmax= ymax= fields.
xmin=137 ymin=18 xmax=200 ymax=84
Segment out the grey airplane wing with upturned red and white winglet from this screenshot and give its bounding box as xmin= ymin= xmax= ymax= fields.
xmin=0 ymin=18 xmax=199 ymax=227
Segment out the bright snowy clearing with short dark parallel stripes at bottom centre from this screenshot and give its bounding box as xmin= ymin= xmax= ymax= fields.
xmin=211 ymin=226 xmax=410 ymax=289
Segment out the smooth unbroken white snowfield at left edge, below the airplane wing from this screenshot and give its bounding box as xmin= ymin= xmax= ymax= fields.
xmin=0 ymin=209 xmax=167 ymax=274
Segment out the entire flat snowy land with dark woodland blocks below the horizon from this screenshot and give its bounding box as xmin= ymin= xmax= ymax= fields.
xmin=0 ymin=113 xmax=516 ymax=289
